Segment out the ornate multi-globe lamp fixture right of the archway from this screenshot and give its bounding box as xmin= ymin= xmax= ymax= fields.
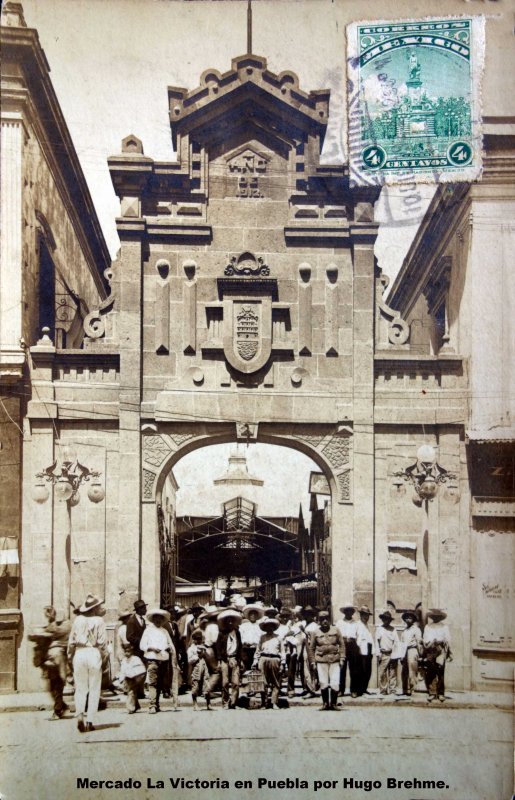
xmin=394 ymin=444 xmax=459 ymax=506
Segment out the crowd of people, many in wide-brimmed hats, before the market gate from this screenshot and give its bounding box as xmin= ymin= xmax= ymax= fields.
xmin=31 ymin=595 xmax=452 ymax=732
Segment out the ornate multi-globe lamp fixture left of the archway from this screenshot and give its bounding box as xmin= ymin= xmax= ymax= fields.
xmin=32 ymin=445 xmax=105 ymax=506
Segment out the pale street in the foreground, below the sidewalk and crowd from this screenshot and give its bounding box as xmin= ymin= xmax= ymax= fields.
xmin=0 ymin=695 xmax=513 ymax=800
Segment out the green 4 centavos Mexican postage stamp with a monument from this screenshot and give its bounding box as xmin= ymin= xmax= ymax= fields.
xmin=347 ymin=17 xmax=485 ymax=185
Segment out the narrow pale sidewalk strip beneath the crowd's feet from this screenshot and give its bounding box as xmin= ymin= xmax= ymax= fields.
xmin=0 ymin=689 xmax=514 ymax=713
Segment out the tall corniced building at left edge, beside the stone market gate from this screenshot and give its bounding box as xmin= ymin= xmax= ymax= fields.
xmin=0 ymin=2 xmax=110 ymax=690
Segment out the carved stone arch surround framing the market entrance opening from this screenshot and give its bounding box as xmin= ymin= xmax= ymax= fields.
xmin=141 ymin=422 xmax=354 ymax=609
